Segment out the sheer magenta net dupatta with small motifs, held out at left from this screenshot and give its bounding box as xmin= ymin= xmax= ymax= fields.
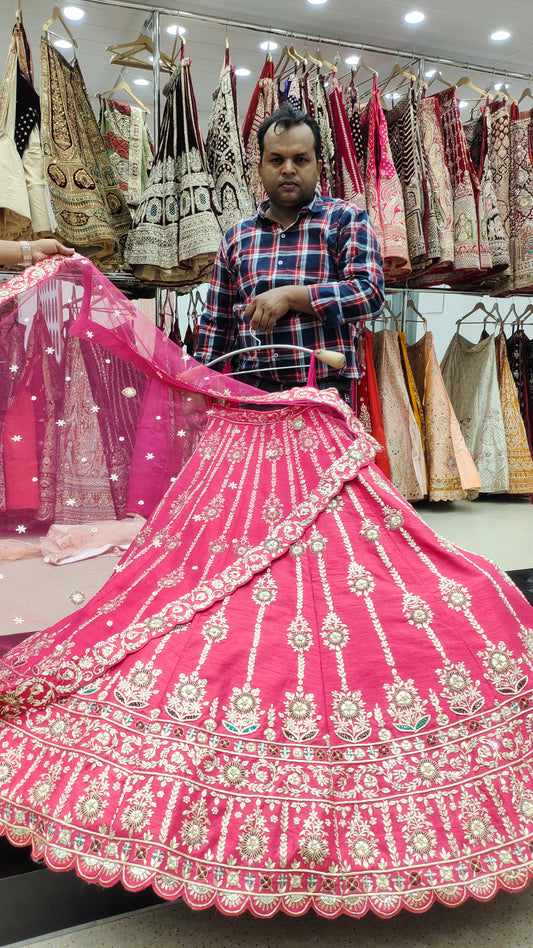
xmin=0 ymin=255 xmax=362 ymax=529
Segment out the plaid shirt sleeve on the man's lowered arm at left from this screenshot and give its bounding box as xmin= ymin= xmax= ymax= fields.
xmin=194 ymin=239 xmax=234 ymax=370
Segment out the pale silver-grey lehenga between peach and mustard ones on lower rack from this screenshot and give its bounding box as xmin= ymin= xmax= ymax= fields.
xmin=441 ymin=332 xmax=509 ymax=494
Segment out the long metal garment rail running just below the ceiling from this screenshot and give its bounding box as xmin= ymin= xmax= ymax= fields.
xmin=82 ymin=0 xmax=533 ymax=82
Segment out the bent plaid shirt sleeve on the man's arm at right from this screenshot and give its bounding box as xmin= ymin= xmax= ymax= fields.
xmin=309 ymin=207 xmax=384 ymax=326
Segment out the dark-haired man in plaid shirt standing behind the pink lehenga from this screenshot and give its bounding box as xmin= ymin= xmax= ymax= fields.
xmin=195 ymin=105 xmax=383 ymax=401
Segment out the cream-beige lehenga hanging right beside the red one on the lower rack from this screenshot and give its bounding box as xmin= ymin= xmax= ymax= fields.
xmin=372 ymin=329 xmax=427 ymax=500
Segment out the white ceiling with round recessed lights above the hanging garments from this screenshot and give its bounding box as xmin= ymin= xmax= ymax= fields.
xmin=0 ymin=0 xmax=533 ymax=132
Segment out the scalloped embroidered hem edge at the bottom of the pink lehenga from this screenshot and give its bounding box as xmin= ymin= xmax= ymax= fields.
xmin=0 ymin=823 xmax=533 ymax=918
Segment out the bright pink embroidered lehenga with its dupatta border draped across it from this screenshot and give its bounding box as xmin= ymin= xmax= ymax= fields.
xmin=0 ymin=258 xmax=533 ymax=917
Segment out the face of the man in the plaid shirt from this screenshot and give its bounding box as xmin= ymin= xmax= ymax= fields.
xmin=261 ymin=124 xmax=321 ymax=211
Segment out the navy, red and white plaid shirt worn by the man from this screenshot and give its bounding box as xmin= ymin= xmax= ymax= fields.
xmin=195 ymin=195 xmax=383 ymax=385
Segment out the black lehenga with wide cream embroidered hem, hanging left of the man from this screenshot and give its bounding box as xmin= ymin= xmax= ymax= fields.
xmin=125 ymin=57 xmax=222 ymax=286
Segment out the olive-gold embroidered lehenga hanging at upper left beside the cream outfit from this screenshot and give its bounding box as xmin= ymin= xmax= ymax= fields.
xmin=41 ymin=39 xmax=131 ymax=270
